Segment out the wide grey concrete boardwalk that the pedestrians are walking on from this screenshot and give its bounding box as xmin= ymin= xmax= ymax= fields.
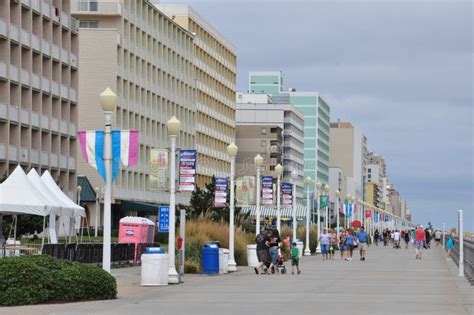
xmin=0 ymin=246 xmax=474 ymax=315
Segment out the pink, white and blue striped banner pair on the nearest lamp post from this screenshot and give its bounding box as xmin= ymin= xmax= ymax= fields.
xmin=77 ymin=129 xmax=138 ymax=183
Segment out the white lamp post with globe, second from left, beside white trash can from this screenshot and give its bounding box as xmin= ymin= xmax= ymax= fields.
xmin=166 ymin=116 xmax=181 ymax=283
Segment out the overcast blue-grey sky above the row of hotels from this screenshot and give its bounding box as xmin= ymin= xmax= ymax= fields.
xmin=161 ymin=0 xmax=474 ymax=231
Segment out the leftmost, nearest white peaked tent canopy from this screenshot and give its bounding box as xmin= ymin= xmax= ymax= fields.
xmin=0 ymin=166 xmax=53 ymax=217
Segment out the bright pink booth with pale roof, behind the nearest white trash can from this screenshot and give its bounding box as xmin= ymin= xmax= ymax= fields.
xmin=119 ymin=217 xmax=155 ymax=263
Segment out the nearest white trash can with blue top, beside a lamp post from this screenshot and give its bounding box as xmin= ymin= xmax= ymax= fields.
xmin=141 ymin=247 xmax=169 ymax=286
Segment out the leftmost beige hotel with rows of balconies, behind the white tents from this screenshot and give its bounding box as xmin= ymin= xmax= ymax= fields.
xmin=0 ymin=0 xmax=79 ymax=199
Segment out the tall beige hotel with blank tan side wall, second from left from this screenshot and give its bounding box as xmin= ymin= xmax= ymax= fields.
xmin=71 ymin=0 xmax=196 ymax=215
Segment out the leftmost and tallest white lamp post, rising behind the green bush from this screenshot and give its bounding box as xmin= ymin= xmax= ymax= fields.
xmin=99 ymin=88 xmax=117 ymax=273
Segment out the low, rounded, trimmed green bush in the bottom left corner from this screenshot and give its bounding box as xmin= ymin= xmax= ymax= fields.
xmin=0 ymin=256 xmax=117 ymax=306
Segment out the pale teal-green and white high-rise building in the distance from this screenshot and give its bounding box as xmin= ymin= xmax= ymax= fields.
xmin=248 ymin=71 xmax=330 ymax=195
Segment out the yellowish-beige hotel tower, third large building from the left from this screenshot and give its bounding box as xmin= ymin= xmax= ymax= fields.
xmin=159 ymin=4 xmax=237 ymax=187
